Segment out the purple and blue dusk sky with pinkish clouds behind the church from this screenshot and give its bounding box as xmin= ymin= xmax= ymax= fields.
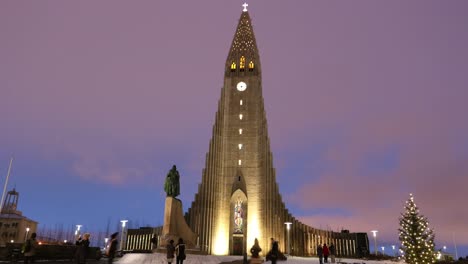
xmin=0 ymin=0 xmax=468 ymax=256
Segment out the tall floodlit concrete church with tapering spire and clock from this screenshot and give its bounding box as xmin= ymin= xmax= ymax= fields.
xmin=186 ymin=4 xmax=368 ymax=255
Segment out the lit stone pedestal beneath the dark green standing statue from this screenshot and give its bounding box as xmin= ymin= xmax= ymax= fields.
xmin=160 ymin=197 xmax=198 ymax=248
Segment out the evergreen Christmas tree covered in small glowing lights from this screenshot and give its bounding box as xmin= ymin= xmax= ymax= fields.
xmin=398 ymin=194 xmax=436 ymax=264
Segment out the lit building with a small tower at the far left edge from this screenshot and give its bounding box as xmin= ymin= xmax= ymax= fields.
xmin=0 ymin=189 xmax=38 ymax=246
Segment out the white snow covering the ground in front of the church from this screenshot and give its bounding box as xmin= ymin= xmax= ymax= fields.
xmin=116 ymin=253 xmax=403 ymax=264
